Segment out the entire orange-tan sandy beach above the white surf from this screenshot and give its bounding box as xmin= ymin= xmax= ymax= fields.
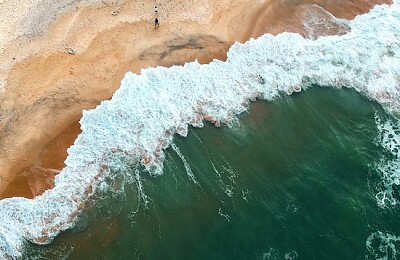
xmin=0 ymin=0 xmax=391 ymax=198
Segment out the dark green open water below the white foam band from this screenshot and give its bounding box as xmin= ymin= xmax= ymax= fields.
xmin=27 ymin=87 xmax=400 ymax=259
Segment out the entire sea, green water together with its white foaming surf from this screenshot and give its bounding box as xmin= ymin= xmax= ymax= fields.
xmin=0 ymin=2 xmax=400 ymax=259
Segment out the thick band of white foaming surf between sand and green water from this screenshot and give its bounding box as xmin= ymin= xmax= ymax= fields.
xmin=0 ymin=2 xmax=400 ymax=259
